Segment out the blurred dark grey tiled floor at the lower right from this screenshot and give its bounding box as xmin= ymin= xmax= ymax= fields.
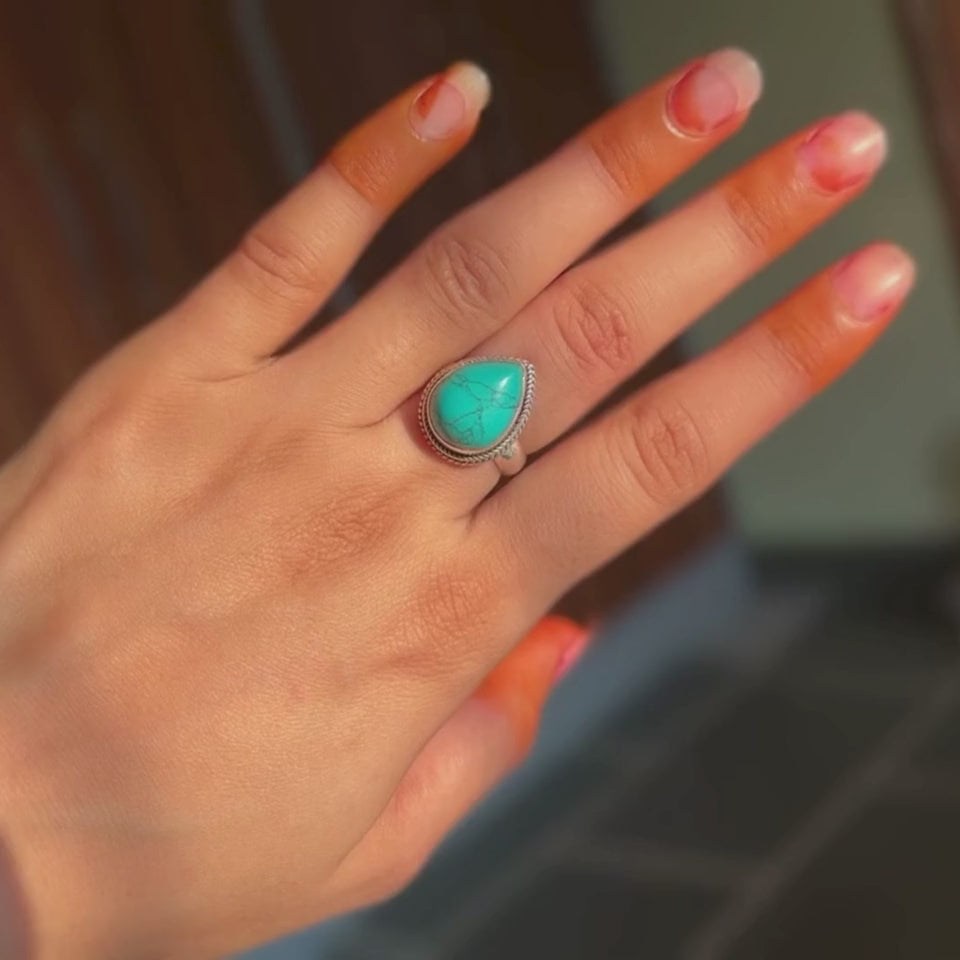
xmin=334 ymin=577 xmax=960 ymax=960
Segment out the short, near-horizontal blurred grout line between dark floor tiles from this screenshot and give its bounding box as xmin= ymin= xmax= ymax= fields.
xmin=555 ymin=837 xmax=758 ymax=889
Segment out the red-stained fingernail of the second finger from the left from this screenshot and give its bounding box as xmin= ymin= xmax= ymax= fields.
xmin=667 ymin=49 xmax=763 ymax=136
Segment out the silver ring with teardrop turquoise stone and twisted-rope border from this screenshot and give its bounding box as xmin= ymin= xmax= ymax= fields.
xmin=420 ymin=357 xmax=536 ymax=476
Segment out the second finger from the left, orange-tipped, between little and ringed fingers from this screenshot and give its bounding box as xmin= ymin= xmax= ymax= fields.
xmin=300 ymin=50 xmax=761 ymax=424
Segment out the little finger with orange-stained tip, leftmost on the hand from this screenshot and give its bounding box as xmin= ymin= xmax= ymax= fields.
xmin=166 ymin=63 xmax=490 ymax=374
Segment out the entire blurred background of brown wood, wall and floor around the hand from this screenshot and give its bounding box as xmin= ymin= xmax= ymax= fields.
xmin=0 ymin=0 xmax=960 ymax=960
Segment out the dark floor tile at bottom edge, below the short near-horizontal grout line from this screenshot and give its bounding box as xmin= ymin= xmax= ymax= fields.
xmin=454 ymin=867 xmax=717 ymax=960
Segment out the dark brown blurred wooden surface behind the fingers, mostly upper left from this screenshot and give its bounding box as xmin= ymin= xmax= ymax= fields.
xmin=0 ymin=0 xmax=723 ymax=616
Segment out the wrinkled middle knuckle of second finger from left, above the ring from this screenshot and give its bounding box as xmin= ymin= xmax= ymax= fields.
xmin=424 ymin=233 xmax=510 ymax=322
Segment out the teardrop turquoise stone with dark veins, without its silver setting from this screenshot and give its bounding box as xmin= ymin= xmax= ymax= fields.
xmin=429 ymin=360 xmax=524 ymax=453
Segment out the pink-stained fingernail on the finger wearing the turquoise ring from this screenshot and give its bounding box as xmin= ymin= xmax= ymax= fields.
xmin=800 ymin=111 xmax=887 ymax=193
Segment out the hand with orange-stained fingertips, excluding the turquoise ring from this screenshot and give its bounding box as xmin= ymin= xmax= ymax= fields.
xmin=0 ymin=51 xmax=913 ymax=960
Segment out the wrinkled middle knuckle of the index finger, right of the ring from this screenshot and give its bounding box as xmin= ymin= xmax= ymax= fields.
xmin=620 ymin=403 xmax=710 ymax=507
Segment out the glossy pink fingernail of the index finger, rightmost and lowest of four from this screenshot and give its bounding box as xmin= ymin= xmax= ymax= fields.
xmin=833 ymin=243 xmax=916 ymax=323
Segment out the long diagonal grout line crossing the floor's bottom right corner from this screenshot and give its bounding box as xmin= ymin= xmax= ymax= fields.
xmin=682 ymin=667 xmax=960 ymax=960
